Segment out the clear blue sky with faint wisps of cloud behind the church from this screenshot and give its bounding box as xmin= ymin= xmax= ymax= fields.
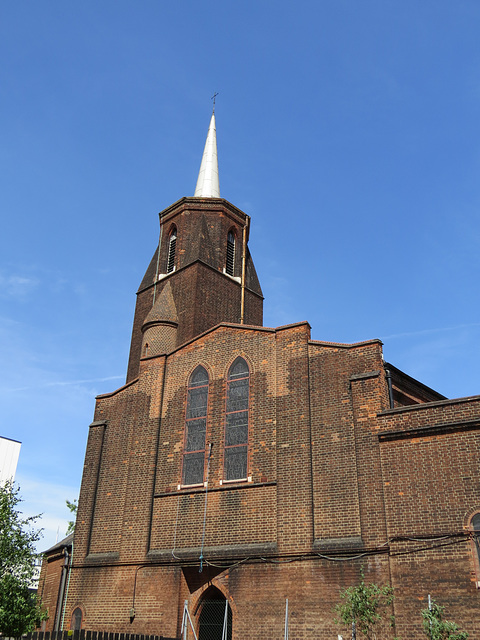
xmin=0 ymin=0 xmax=480 ymax=548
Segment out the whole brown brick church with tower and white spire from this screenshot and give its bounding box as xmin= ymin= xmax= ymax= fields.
xmin=40 ymin=115 xmax=480 ymax=640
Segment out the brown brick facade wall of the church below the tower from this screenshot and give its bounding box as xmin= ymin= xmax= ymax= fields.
xmin=59 ymin=323 xmax=480 ymax=640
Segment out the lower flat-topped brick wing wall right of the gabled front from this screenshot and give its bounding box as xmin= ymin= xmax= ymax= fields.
xmin=379 ymin=397 xmax=480 ymax=637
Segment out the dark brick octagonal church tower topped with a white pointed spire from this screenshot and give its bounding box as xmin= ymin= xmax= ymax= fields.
xmin=127 ymin=112 xmax=263 ymax=382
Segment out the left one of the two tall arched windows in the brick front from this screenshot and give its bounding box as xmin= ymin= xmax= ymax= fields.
xmin=182 ymin=365 xmax=209 ymax=484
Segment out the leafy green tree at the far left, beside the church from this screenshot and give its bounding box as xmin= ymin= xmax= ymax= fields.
xmin=0 ymin=482 xmax=47 ymax=637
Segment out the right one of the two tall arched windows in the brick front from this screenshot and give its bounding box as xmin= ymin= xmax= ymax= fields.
xmin=224 ymin=357 xmax=250 ymax=480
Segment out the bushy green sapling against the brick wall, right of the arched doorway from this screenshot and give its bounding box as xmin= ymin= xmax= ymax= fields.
xmin=335 ymin=569 xmax=393 ymax=640
